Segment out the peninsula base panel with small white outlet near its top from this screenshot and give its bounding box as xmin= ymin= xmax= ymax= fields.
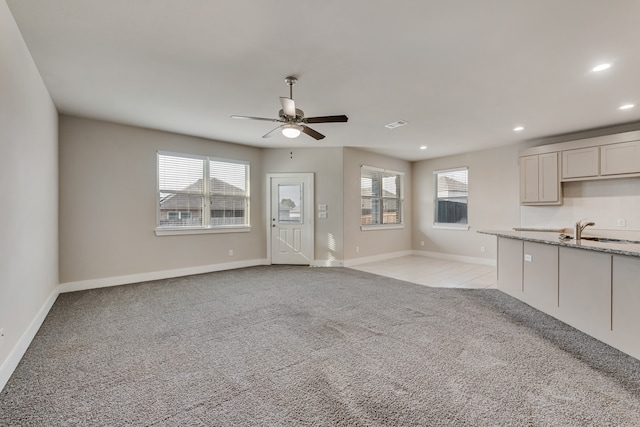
xmin=522 ymin=242 xmax=558 ymax=316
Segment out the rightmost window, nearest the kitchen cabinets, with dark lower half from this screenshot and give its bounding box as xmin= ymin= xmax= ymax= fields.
xmin=433 ymin=168 xmax=469 ymax=229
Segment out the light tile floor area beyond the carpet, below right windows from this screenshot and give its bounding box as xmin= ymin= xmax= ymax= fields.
xmin=351 ymin=255 xmax=496 ymax=288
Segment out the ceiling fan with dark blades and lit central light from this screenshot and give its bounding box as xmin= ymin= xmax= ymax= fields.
xmin=231 ymin=76 xmax=349 ymax=140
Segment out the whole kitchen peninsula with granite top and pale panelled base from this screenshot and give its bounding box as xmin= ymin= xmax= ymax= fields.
xmin=480 ymin=229 xmax=640 ymax=360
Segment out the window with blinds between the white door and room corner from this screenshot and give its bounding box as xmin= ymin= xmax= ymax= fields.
xmin=360 ymin=166 xmax=404 ymax=229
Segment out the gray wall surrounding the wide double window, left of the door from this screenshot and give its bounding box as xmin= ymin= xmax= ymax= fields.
xmin=59 ymin=116 xmax=266 ymax=283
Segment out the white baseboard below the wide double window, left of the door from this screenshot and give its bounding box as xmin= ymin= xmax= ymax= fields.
xmin=58 ymin=259 xmax=269 ymax=293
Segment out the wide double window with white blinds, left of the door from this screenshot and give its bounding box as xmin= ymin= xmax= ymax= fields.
xmin=157 ymin=153 xmax=249 ymax=234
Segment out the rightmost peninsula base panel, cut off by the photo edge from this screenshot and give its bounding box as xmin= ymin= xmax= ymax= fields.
xmin=611 ymin=255 xmax=640 ymax=359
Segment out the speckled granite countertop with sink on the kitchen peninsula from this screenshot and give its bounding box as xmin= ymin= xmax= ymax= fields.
xmin=478 ymin=229 xmax=640 ymax=257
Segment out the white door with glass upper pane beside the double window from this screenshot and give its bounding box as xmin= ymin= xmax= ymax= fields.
xmin=267 ymin=173 xmax=314 ymax=265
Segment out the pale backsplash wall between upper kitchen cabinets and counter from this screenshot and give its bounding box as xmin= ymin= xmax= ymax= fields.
xmin=520 ymin=178 xmax=640 ymax=234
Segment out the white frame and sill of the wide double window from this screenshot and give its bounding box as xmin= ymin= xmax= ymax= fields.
xmin=155 ymin=151 xmax=251 ymax=236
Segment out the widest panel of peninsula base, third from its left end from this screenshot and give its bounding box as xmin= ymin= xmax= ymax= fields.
xmin=558 ymin=247 xmax=611 ymax=341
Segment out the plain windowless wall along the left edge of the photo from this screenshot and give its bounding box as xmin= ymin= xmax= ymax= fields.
xmin=0 ymin=0 xmax=58 ymax=380
